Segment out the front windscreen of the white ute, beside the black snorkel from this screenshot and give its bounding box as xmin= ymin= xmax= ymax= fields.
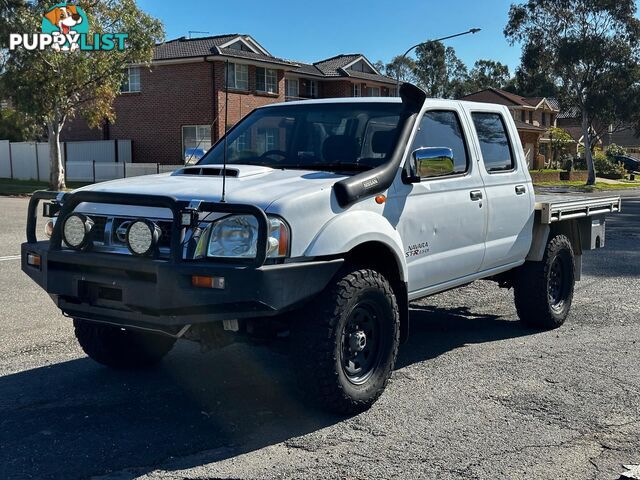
xmin=198 ymin=102 xmax=403 ymax=171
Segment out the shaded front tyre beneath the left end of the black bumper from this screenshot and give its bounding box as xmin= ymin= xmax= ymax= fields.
xmin=73 ymin=319 xmax=176 ymax=370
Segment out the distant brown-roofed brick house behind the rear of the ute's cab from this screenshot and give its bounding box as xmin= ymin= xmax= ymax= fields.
xmin=462 ymin=88 xmax=560 ymax=169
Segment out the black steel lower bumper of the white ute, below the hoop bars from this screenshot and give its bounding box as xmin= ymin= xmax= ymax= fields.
xmin=22 ymin=242 xmax=343 ymax=330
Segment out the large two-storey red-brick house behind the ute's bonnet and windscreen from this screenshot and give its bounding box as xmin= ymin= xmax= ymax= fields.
xmin=62 ymin=34 xmax=396 ymax=164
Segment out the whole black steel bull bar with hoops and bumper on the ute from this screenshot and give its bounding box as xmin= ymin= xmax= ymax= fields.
xmin=22 ymin=191 xmax=343 ymax=333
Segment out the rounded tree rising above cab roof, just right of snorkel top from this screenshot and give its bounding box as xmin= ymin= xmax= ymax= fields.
xmin=415 ymin=42 xmax=468 ymax=98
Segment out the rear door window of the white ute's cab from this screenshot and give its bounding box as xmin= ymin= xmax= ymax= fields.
xmin=471 ymin=112 xmax=515 ymax=173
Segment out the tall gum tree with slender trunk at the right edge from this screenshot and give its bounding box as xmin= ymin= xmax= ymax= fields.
xmin=504 ymin=0 xmax=640 ymax=185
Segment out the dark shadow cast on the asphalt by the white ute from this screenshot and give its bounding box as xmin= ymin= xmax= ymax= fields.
xmin=0 ymin=305 xmax=534 ymax=479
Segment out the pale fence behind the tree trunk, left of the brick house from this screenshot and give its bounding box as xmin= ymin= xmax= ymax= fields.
xmin=0 ymin=140 xmax=182 ymax=183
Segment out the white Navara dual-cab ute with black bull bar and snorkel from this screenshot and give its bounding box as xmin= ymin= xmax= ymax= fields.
xmin=22 ymin=84 xmax=621 ymax=413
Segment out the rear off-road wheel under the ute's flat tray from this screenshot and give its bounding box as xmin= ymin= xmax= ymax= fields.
xmin=514 ymin=235 xmax=575 ymax=330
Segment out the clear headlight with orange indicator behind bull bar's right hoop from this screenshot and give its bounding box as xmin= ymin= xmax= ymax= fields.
xmin=207 ymin=215 xmax=290 ymax=258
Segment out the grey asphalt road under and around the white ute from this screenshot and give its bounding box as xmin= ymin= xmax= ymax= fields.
xmin=0 ymin=193 xmax=640 ymax=480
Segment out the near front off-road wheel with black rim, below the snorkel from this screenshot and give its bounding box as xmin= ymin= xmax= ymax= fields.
xmin=291 ymin=269 xmax=400 ymax=415
